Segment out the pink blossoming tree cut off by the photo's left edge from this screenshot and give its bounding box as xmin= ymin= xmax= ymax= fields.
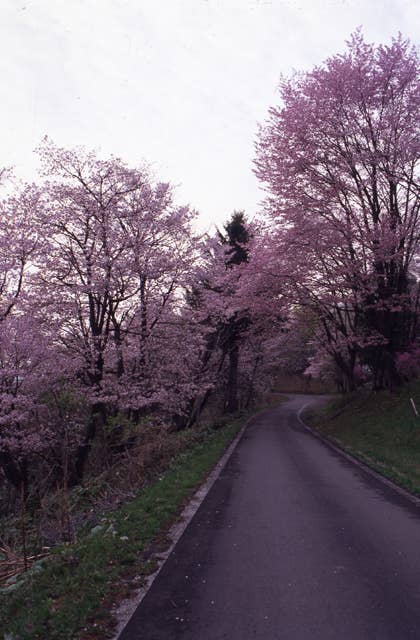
xmin=0 ymin=182 xmax=53 ymax=493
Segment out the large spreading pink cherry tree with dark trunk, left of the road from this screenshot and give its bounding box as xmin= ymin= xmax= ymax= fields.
xmin=34 ymin=140 xmax=199 ymax=482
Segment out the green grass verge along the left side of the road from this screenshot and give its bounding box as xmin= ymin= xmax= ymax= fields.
xmin=0 ymin=417 xmax=249 ymax=640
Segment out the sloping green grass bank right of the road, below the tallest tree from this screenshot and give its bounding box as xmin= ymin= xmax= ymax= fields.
xmin=304 ymin=381 xmax=420 ymax=495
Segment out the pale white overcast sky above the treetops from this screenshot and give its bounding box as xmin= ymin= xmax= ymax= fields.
xmin=0 ymin=0 xmax=420 ymax=227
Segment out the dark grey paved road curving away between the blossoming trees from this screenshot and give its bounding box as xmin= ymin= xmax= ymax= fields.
xmin=121 ymin=396 xmax=420 ymax=640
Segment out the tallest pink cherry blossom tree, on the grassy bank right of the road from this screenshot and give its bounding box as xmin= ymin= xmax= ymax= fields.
xmin=256 ymin=31 xmax=420 ymax=388
